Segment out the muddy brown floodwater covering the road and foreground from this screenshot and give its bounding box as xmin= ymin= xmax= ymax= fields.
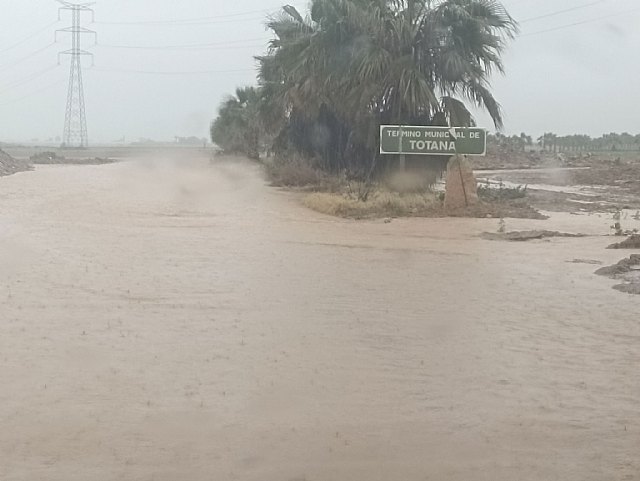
xmin=0 ymin=151 xmax=640 ymax=481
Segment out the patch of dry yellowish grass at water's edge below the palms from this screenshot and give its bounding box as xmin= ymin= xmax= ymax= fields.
xmin=304 ymin=191 xmax=442 ymax=219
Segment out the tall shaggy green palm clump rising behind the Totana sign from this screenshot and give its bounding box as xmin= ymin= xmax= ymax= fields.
xmin=258 ymin=0 xmax=517 ymax=172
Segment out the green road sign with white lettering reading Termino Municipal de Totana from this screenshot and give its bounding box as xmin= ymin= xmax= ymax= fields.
xmin=380 ymin=125 xmax=487 ymax=155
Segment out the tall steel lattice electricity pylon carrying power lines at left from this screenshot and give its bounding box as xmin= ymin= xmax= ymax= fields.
xmin=56 ymin=0 xmax=97 ymax=148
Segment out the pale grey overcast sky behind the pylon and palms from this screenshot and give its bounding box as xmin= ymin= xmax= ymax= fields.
xmin=0 ymin=0 xmax=640 ymax=143
